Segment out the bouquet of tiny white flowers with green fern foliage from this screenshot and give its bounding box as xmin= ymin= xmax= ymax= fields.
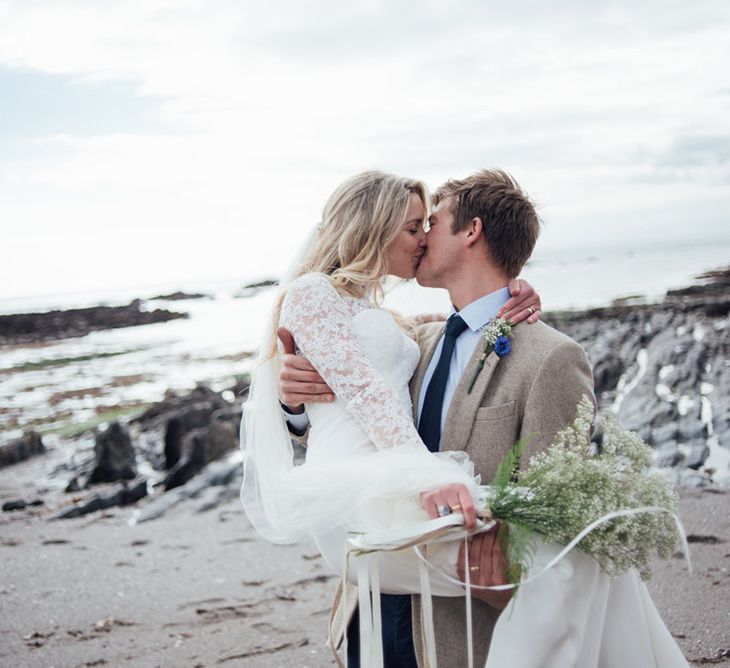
xmin=483 ymin=397 xmax=678 ymax=583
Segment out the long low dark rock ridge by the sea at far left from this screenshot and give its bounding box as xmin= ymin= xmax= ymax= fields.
xmin=0 ymin=299 xmax=188 ymax=345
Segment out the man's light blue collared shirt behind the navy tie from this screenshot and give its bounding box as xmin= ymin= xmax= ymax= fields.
xmin=418 ymin=288 xmax=509 ymax=446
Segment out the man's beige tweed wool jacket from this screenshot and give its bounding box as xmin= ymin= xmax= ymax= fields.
xmin=330 ymin=322 xmax=595 ymax=668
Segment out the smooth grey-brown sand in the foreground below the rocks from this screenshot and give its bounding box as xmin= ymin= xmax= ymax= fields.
xmin=0 ymin=451 xmax=730 ymax=668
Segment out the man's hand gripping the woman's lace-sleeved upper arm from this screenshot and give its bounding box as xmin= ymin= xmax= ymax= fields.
xmin=276 ymin=327 xmax=335 ymax=414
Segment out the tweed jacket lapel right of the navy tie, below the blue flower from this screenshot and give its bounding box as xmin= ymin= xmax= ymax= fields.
xmin=441 ymin=340 xmax=500 ymax=450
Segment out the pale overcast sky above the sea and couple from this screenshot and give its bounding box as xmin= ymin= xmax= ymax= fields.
xmin=0 ymin=0 xmax=730 ymax=296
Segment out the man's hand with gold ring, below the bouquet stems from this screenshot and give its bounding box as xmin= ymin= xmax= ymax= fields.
xmin=456 ymin=525 xmax=514 ymax=610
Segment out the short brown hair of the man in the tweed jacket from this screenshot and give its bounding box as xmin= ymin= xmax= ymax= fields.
xmin=433 ymin=169 xmax=540 ymax=278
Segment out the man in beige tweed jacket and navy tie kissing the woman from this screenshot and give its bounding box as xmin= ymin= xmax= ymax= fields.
xmin=281 ymin=170 xmax=593 ymax=668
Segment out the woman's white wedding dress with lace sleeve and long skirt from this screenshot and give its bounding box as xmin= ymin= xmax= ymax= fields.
xmin=246 ymin=275 xmax=687 ymax=668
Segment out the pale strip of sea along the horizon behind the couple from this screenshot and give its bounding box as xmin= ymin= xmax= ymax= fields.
xmin=0 ymin=238 xmax=730 ymax=315
